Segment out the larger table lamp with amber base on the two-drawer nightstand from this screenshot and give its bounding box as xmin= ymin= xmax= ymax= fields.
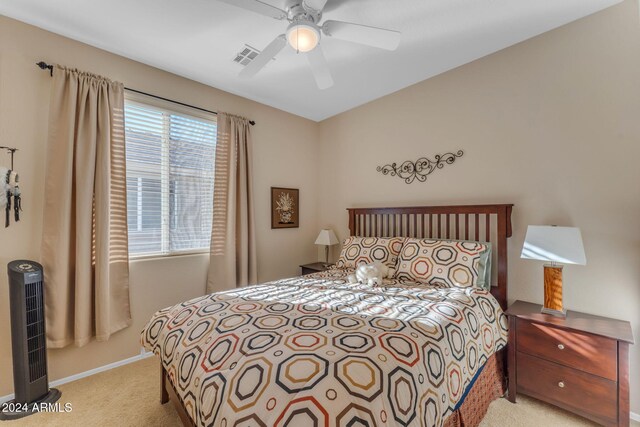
xmin=520 ymin=225 xmax=587 ymax=317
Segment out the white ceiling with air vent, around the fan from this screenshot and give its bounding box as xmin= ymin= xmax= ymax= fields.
xmin=0 ymin=0 xmax=620 ymax=121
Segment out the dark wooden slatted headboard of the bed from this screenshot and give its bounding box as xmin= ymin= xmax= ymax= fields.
xmin=347 ymin=205 xmax=513 ymax=310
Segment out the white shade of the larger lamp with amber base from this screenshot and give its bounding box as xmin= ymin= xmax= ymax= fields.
xmin=520 ymin=225 xmax=587 ymax=265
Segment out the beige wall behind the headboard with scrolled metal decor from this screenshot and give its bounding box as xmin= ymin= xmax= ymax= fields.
xmin=318 ymin=0 xmax=640 ymax=413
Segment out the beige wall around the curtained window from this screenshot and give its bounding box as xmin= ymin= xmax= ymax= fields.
xmin=0 ymin=16 xmax=318 ymax=396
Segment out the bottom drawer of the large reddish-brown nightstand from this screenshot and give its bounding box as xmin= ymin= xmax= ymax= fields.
xmin=517 ymin=352 xmax=618 ymax=424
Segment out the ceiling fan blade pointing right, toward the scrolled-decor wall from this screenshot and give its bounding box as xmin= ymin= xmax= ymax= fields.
xmin=322 ymin=21 xmax=402 ymax=50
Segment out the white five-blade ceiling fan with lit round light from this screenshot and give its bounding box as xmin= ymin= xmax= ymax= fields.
xmin=219 ymin=0 xmax=401 ymax=89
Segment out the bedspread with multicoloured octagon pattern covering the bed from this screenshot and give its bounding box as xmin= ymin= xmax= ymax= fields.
xmin=142 ymin=270 xmax=507 ymax=427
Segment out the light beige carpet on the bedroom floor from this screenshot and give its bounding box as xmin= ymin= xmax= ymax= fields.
xmin=0 ymin=357 xmax=640 ymax=427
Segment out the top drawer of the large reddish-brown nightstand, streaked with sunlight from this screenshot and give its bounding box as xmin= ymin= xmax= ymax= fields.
xmin=516 ymin=319 xmax=618 ymax=381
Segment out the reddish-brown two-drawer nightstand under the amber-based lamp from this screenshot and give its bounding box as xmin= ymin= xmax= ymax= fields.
xmin=506 ymin=301 xmax=633 ymax=426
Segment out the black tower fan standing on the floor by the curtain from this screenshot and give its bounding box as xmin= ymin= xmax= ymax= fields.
xmin=0 ymin=260 xmax=61 ymax=420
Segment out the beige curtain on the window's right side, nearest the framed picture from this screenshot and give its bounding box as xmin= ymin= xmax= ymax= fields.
xmin=207 ymin=113 xmax=258 ymax=292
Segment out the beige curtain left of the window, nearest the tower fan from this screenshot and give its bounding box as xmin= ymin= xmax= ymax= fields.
xmin=41 ymin=66 xmax=131 ymax=348
